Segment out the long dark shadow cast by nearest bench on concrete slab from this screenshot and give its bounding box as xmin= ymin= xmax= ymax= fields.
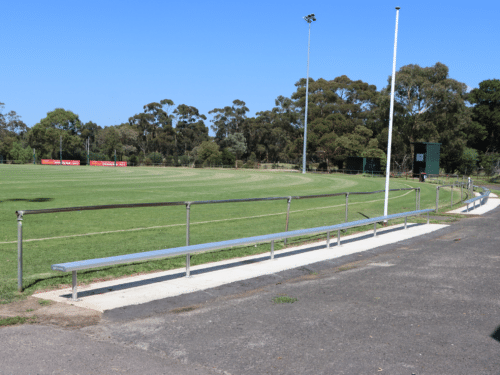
xmin=60 ymin=223 xmax=425 ymax=298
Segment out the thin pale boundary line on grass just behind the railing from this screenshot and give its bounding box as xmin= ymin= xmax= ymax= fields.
xmin=0 ymin=191 xmax=411 ymax=245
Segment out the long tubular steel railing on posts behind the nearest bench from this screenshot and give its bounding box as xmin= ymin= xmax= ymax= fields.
xmin=16 ymin=188 xmax=420 ymax=292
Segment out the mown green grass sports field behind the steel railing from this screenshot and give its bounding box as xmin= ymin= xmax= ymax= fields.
xmin=0 ymin=165 xmax=460 ymax=302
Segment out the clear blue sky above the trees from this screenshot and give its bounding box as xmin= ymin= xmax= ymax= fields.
xmin=0 ymin=0 xmax=500 ymax=134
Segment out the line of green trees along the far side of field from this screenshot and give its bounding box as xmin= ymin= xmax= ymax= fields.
xmin=0 ymin=62 xmax=500 ymax=173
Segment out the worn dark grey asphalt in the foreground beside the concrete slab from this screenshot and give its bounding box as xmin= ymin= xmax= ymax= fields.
xmin=0 ymin=201 xmax=500 ymax=375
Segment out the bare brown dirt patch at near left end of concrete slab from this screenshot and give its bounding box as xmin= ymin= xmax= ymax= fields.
xmin=0 ymin=297 xmax=101 ymax=329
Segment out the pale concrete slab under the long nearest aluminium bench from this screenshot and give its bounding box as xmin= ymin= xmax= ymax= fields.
xmin=33 ymin=224 xmax=447 ymax=312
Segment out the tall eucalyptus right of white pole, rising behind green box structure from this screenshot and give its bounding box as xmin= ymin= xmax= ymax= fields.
xmin=386 ymin=62 xmax=477 ymax=172
